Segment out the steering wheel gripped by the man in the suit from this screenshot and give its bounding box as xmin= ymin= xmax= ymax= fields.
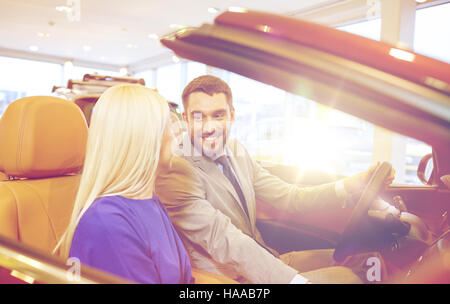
xmin=333 ymin=162 xmax=392 ymax=262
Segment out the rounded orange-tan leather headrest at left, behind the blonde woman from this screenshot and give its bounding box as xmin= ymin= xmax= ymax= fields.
xmin=0 ymin=96 xmax=87 ymax=178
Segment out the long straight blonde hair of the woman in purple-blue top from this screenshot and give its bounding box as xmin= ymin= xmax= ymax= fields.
xmin=54 ymin=85 xmax=169 ymax=258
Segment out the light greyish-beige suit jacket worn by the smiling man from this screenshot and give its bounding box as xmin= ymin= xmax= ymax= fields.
xmin=155 ymin=140 xmax=342 ymax=283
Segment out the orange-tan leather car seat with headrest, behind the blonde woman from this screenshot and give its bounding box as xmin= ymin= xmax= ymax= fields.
xmin=0 ymin=96 xmax=87 ymax=252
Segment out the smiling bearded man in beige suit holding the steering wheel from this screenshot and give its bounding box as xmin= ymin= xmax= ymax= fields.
xmin=155 ymin=75 xmax=393 ymax=283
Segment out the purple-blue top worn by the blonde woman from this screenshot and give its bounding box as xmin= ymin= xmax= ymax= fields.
xmin=70 ymin=196 xmax=192 ymax=284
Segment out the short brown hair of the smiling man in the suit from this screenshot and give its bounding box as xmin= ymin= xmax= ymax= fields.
xmin=181 ymin=75 xmax=233 ymax=111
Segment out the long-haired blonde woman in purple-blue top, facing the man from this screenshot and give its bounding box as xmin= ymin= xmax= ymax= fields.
xmin=56 ymin=85 xmax=191 ymax=283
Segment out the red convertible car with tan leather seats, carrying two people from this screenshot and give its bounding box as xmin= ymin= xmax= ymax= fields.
xmin=0 ymin=9 xmax=450 ymax=283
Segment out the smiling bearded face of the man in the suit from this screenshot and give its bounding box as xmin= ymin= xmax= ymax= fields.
xmin=183 ymin=92 xmax=234 ymax=158
